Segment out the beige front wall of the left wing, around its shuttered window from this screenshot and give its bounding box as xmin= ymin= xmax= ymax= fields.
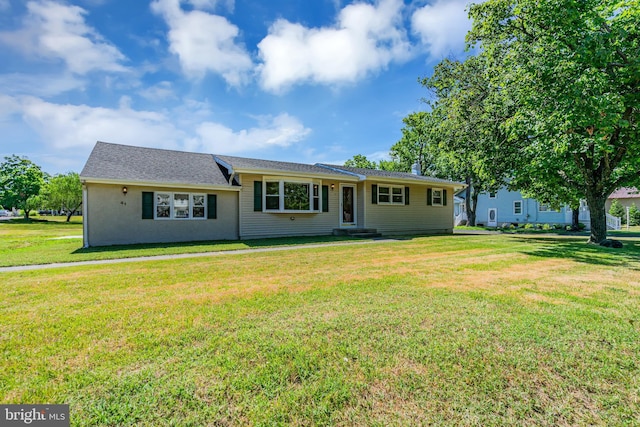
xmin=85 ymin=183 xmax=238 ymax=246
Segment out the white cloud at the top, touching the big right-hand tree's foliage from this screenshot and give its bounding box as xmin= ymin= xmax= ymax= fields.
xmin=411 ymin=0 xmax=471 ymax=57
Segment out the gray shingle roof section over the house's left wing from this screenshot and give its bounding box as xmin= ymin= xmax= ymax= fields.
xmin=80 ymin=142 xmax=228 ymax=186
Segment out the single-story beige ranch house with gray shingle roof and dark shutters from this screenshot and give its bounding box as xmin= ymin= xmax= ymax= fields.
xmin=80 ymin=142 xmax=464 ymax=247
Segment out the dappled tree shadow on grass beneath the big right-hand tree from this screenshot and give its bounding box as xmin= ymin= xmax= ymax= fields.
xmin=514 ymin=236 xmax=640 ymax=270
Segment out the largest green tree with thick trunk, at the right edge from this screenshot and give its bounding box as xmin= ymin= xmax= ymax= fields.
xmin=468 ymin=0 xmax=640 ymax=243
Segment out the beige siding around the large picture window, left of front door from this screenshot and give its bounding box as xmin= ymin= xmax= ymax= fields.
xmin=240 ymin=175 xmax=340 ymax=239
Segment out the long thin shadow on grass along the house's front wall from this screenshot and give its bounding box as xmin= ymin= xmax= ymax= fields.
xmin=72 ymin=236 xmax=362 ymax=254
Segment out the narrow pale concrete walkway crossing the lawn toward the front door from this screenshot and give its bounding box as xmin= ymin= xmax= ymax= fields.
xmin=0 ymin=239 xmax=397 ymax=273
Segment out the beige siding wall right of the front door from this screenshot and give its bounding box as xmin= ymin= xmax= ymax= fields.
xmin=364 ymin=182 xmax=453 ymax=234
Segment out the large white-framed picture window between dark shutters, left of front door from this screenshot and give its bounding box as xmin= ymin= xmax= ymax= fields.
xmin=264 ymin=179 xmax=321 ymax=212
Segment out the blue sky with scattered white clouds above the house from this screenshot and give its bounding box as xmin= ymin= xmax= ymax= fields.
xmin=0 ymin=0 xmax=471 ymax=174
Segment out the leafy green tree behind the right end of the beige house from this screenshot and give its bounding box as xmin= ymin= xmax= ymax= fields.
xmin=391 ymin=56 xmax=513 ymax=225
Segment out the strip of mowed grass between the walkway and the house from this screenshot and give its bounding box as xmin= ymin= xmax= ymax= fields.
xmin=0 ymin=221 xmax=354 ymax=267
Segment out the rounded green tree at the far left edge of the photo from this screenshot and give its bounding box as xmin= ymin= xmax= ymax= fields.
xmin=0 ymin=155 xmax=44 ymax=219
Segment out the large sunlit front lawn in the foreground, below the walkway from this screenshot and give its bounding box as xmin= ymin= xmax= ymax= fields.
xmin=0 ymin=235 xmax=640 ymax=426
